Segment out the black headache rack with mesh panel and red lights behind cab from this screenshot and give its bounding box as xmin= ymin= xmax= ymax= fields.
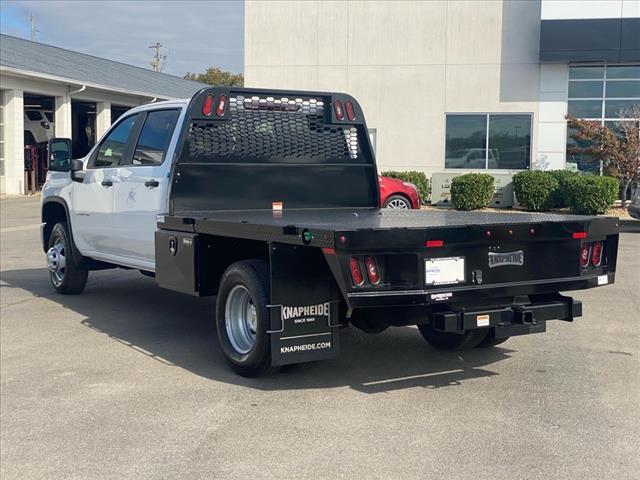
xmin=170 ymin=88 xmax=379 ymax=214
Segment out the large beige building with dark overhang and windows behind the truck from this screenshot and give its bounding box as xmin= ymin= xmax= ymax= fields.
xmin=245 ymin=0 xmax=640 ymax=175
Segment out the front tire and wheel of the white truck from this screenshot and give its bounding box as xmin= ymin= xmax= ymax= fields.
xmin=47 ymin=222 xmax=89 ymax=295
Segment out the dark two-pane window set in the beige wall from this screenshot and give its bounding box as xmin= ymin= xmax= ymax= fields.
xmin=445 ymin=113 xmax=531 ymax=170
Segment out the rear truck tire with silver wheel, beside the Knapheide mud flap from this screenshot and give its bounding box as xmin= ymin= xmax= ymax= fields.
xmin=216 ymin=260 xmax=275 ymax=377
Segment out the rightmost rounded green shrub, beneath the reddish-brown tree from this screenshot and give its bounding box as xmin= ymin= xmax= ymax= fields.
xmin=567 ymin=175 xmax=620 ymax=215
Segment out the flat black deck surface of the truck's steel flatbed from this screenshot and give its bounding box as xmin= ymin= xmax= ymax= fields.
xmin=158 ymin=208 xmax=618 ymax=248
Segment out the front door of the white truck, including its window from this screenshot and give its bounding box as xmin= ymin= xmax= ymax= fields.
xmin=71 ymin=114 xmax=143 ymax=254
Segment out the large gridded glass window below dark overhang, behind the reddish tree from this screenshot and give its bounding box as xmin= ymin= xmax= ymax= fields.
xmin=567 ymin=65 xmax=640 ymax=172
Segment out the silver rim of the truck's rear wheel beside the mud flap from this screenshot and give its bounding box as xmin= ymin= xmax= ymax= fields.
xmin=224 ymin=285 xmax=258 ymax=354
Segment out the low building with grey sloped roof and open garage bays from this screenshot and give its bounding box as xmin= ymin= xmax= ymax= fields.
xmin=0 ymin=35 xmax=204 ymax=194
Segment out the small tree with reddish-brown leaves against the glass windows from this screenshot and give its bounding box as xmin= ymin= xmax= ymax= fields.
xmin=566 ymin=106 xmax=640 ymax=207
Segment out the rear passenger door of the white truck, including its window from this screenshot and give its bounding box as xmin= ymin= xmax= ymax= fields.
xmin=114 ymin=108 xmax=180 ymax=269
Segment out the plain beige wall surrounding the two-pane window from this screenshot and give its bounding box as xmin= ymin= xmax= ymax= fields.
xmin=245 ymin=0 xmax=540 ymax=174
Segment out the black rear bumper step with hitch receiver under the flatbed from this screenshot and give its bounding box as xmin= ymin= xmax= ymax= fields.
xmin=431 ymin=295 xmax=582 ymax=338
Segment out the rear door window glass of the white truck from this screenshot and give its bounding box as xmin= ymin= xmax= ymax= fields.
xmin=132 ymin=110 xmax=179 ymax=165
